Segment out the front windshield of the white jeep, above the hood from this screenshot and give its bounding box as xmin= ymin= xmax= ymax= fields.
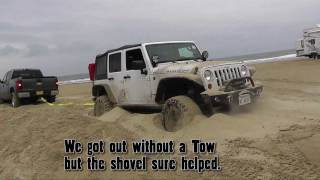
xmin=146 ymin=43 xmax=202 ymax=64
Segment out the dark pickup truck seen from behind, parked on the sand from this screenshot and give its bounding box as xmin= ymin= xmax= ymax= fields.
xmin=0 ymin=69 xmax=59 ymax=107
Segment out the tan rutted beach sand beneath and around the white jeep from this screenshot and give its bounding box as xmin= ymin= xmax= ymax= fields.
xmin=0 ymin=59 xmax=320 ymax=179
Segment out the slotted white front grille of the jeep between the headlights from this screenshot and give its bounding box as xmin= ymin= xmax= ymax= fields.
xmin=214 ymin=67 xmax=241 ymax=86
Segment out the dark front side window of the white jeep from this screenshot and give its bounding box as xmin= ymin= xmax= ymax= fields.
xmin=126 ymin=49 xmax=146 ymax=70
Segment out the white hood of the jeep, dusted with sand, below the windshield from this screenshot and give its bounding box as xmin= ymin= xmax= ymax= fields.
xmin=154 ymin=60 xmax=242 ymax=74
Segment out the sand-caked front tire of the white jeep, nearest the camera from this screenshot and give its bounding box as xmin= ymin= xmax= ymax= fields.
xmin=162 ymin=96 xmax=201 ymax=132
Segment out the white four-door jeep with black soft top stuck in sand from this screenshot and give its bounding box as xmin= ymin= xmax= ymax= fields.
xmin=92 ymin=41 xmax=263 ymax=131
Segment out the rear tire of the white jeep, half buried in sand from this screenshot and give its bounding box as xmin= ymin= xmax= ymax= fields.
xmin=94 ymin=95 xmax=114 ymax=116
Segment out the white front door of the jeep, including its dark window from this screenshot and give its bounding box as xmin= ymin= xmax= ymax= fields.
xmin=123 ymin=48 xmax=152 ymax=105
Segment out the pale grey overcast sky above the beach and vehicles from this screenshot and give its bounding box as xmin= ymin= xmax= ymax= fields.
xmin=0 ymin=0 xmax=320 ymax=77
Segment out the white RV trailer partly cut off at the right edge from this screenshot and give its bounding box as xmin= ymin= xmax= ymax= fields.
xmin=296 ymin=27 xmax=320 ymax=59
